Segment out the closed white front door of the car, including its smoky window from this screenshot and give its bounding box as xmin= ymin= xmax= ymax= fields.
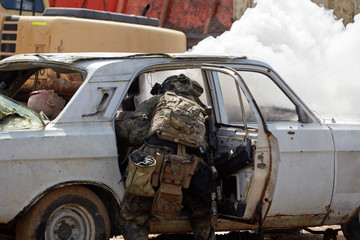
xmin=238 ymin=68 xmax=334 ymax=226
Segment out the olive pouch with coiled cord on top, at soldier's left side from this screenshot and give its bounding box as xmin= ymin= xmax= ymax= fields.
xmin=125 ymin=151 xmax=156 ymax=197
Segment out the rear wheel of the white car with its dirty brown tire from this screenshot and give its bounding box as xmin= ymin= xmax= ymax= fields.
xmin=16 ymin=186 xmax=110 ymax=240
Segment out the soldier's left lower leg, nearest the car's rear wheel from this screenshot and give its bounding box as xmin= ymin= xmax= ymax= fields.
xmin=120 ymin=193 xmax=153 ymax=240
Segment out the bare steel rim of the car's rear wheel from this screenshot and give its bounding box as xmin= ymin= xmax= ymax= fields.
xmin=45 ymin=204 xmax=95 ymax=240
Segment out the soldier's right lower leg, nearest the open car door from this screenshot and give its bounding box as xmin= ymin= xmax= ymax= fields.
xmin=183 ymin=191 xmax=216 ymax=240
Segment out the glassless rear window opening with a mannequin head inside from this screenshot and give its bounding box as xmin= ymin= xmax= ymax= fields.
xmin=0 ymin=68 xmax=83 ymax=120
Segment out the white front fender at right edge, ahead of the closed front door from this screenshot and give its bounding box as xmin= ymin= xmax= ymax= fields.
xmin=326 ymin=123 xmax=360 ymax=224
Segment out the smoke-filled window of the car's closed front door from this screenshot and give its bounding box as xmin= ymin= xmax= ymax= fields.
xmin=239 ymin=71 xmax=298 ymax=122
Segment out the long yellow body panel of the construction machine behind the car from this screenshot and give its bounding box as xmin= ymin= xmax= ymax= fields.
xmin=2 ymin=16 xmax=186 ymax=55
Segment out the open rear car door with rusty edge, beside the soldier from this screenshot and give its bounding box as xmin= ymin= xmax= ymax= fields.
xmin=202 ymin=65 xmax=276 ymax=223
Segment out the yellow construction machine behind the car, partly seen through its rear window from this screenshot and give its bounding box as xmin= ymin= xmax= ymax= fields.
xmin=0 ymin=0 xmax=186 ymax=101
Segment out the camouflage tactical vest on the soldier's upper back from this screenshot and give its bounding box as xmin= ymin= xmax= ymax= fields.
xmin=149 ymin=91 xmax=206 ymax=148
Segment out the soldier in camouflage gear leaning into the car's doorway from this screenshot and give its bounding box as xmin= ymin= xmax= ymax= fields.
xmin=116 ymin=74 xmax=215 ymax=240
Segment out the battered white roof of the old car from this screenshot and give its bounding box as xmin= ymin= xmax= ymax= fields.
xmin=0 ymin=52 xmax=271 ymax=96
